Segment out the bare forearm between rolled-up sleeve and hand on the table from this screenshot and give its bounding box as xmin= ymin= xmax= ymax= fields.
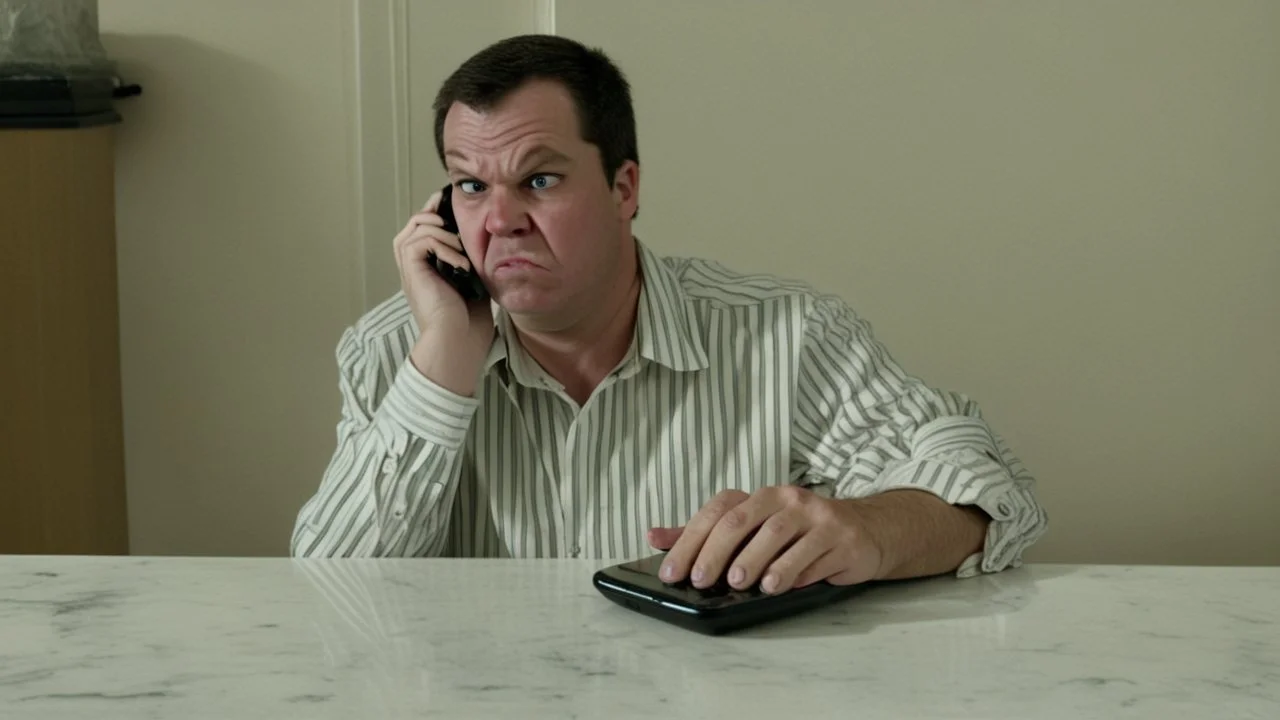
xmin=845 ymin=489 xmax=991 ymax=580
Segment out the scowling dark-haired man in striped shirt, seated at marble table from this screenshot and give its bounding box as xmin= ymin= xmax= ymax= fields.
xmin=292 ymin=36 xmax=1046 ymax=592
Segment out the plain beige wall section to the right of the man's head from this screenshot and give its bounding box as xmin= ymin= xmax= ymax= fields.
xmin=556 ymin=0 xmax=1280 ymax=564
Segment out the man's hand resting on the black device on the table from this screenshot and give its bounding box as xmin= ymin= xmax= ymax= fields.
xmin=649 ymin=486 xmax=883 ymax=593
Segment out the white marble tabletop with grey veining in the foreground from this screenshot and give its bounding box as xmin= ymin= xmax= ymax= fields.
xmin=0 ymin=556 xmax=1280 ymax=720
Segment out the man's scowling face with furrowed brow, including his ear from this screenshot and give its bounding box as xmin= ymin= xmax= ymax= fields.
xmin=443 ymin=82 xmax=639 ymax=324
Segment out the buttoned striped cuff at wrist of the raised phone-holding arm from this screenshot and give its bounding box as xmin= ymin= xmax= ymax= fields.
xmin=378 ymin=360 xmax=480 ymax=454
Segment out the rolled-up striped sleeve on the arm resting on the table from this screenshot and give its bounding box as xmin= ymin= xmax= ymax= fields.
xmin=792 ymin=296 xmax=1048 ymax=577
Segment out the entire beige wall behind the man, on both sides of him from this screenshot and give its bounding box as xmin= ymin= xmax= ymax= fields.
xmin=101 ymin=0 xmax=1280 ymax=562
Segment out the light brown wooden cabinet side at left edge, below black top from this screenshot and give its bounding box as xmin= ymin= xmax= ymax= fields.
xmin=0 ymin=124 xmax=128 ymax=555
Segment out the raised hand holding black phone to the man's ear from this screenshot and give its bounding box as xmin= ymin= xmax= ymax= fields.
xmin=394 ymin=191 xmax=494 ymax=396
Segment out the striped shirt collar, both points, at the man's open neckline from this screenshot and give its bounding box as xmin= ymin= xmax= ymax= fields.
xmin=484 ymin=240 xmax=709 ymax=386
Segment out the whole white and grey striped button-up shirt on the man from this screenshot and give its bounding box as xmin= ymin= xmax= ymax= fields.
xmin=291 ymin=241 xmax=1046 ymax=577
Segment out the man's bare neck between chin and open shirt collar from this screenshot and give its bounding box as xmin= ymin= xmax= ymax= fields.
xmin=513 ymin=245 xmax=641 ymax=406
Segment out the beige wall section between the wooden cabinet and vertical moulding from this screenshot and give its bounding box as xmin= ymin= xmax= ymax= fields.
xmin=100 ymin=0 xmax=360 ymax=555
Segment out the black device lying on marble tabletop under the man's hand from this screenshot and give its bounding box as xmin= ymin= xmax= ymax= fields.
xmin=591 ymin=552 xmax=867 ymax=635
